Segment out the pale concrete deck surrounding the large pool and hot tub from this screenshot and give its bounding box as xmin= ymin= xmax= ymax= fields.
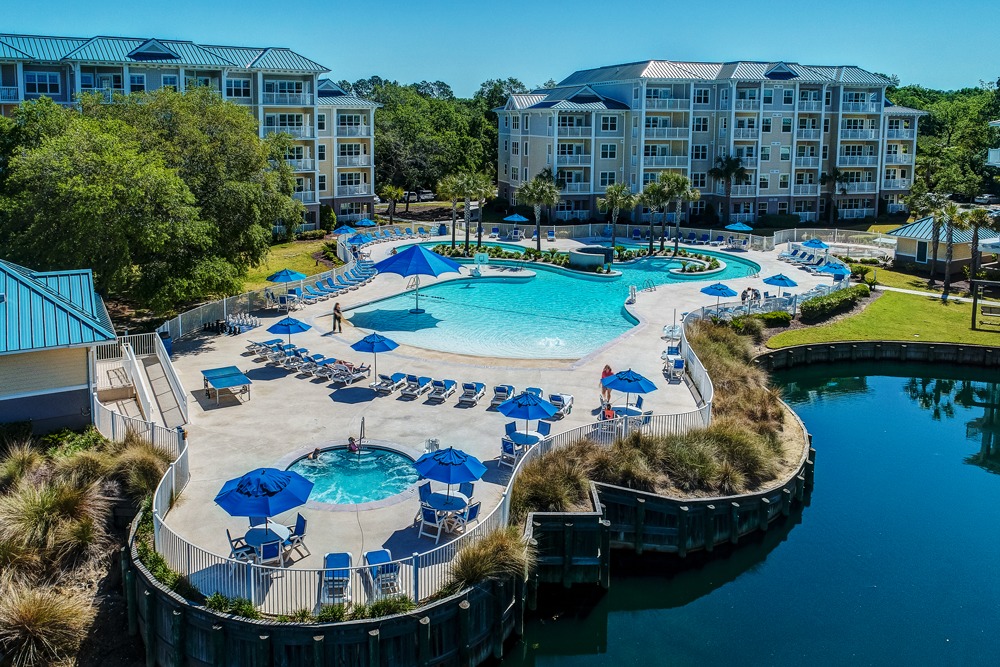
xmin=165 ymin=237 xmax=830 ymax=568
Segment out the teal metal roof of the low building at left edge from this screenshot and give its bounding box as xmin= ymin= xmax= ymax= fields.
xmin=0 ymin=260 xmax=115 ymax=354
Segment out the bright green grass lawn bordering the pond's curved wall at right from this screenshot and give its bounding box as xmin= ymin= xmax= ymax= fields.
xmin=767 ymin=292 xmax=1000 ymax=349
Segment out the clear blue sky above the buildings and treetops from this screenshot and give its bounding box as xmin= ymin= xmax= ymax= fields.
xmin=0 ymin=0 xmax=1000 ymax=96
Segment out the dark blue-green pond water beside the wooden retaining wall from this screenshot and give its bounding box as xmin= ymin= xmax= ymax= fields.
xmin=503 ymin=364 xmax=1000 ymax=667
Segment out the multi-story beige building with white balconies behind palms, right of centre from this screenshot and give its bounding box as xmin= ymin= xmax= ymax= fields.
xmin=496 ymin=60 xmax=923 ymax=222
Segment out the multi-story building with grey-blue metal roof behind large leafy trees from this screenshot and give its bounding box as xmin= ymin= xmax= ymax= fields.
xmin=0 ymin=34 xmax=374 ymax=223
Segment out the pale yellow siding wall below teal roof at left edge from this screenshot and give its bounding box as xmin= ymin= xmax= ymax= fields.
xmin=0 ymin=347 xmax=87 ymax=398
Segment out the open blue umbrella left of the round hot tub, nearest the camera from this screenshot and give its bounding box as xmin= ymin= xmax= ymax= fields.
xmin=215 ymin=468 xmax=313 ymax=527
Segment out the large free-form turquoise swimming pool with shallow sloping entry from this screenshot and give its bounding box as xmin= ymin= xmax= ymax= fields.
xmin=347 ymin=249 xmax=760 ymax=359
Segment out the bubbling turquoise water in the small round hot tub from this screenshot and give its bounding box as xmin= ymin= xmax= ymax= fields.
xmin=288 ymin=447 xmax=420 ymax=504
